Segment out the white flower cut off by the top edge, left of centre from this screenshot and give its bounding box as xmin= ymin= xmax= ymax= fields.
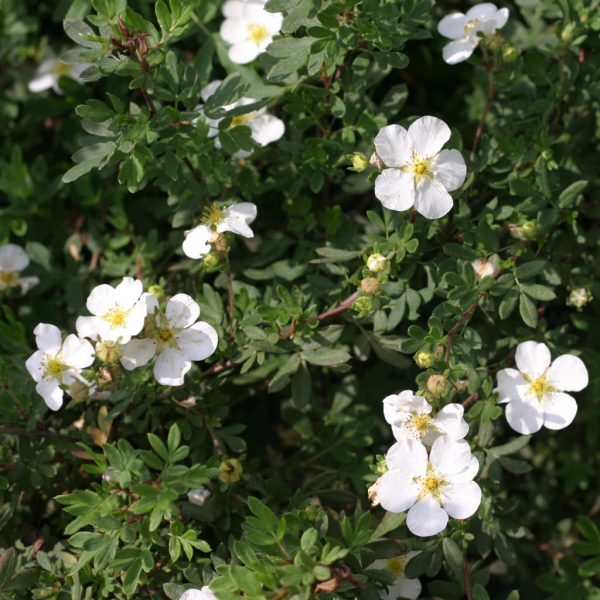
xmin=219 ymin=0 xmax=283 ymax=65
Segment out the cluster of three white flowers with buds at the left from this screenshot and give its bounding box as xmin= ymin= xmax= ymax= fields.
xmin=26 ymin=277 xmax=219 ymax=410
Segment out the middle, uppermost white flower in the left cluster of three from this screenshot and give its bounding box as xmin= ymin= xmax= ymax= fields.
xmin=75 ymin=277 xmax=146 ymax=344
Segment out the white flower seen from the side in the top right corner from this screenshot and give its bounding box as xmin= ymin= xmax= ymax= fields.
xmin=438 ymin=2 xmax=508 ymax=65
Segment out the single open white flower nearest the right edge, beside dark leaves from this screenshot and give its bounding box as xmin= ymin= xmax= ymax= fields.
xmin=496 ymin=342 xmax=588 ymax=434
